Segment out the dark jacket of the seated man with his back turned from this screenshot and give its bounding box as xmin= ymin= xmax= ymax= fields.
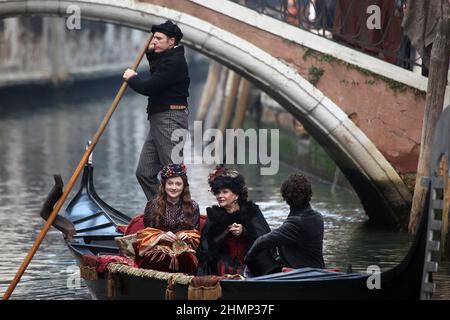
xmin=245 ymin=205 xmax=325 ymax=268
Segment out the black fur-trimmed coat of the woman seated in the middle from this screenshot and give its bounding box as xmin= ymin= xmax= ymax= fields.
xmin=198 ymin=202 xmax=276 ymax=275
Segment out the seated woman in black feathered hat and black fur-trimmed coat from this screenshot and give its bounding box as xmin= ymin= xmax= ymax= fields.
xmin=198 ymin=167 xmax=282 ymax=275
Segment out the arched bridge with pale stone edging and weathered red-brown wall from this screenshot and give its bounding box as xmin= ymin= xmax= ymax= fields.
xmin=0 ymin=0 xmax=427 ymax=225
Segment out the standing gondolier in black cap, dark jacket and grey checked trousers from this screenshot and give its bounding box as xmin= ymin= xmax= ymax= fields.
xmin=123 ymin=21 xmax=190 ymax=200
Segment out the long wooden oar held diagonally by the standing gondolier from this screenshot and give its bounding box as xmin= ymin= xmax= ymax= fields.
xmin=3 ymin=33 xmax=153 ymax=300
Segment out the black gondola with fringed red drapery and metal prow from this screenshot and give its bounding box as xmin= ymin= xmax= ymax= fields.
xmin=41 ymin=107 xmax=450 ymax=300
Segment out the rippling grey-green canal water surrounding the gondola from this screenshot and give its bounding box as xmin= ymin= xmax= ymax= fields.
xmin=0 ymin=63 xmax=409 ymax=299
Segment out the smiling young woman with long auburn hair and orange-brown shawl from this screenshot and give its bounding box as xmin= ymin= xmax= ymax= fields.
xmin=136 ymin=163 xmax=200 ymax=274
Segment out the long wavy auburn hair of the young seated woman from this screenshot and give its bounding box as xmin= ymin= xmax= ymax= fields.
xmin=153 ymin=177 xmax=194 ymax=228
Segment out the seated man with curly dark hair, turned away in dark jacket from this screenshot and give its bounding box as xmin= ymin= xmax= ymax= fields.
xmin=245 ymin=173 xmax=325 ymax=268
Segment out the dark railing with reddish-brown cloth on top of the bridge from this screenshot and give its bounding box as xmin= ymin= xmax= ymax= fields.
xmin=231 ymin=0 xmax=422 ymax=74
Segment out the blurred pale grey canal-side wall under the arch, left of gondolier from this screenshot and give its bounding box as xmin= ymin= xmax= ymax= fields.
xmin=0 ymin=16 xmax=147 ymax=86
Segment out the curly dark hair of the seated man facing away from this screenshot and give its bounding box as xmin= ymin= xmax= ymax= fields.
xmin=281 ymin=173 xmax=312 ymax=208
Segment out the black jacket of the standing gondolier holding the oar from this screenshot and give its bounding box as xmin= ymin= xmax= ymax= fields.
xmin=128 ymin=45 xmax=190 ymax=115
